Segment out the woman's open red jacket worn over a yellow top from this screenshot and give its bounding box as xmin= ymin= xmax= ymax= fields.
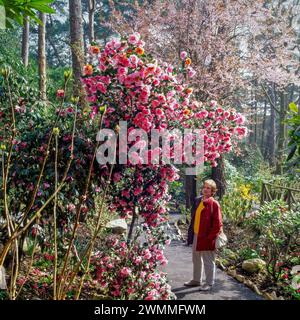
xmin=188 ymin=197 xmax=223 ymax=251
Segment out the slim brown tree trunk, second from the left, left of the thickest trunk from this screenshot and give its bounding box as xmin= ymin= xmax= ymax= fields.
xmin=38 ymin=13 xmax=47 ymax=100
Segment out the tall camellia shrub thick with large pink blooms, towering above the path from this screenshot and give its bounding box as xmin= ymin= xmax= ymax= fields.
xmin=82 ymin=33 xmax=247 ymax=226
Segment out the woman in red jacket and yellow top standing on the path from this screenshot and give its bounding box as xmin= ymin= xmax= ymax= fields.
xmin=184 ymin=180 xmax=222 ymax=291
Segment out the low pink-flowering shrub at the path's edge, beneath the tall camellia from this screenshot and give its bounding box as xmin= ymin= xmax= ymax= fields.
xmin=92 ymin=224 xmax=175 ymax=300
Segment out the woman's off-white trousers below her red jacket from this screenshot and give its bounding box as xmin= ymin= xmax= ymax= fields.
xmin=193 ymin=234 xmax=216 ymax=286
